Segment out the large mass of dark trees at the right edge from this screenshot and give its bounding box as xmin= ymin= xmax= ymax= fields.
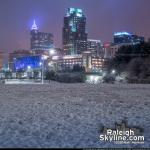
xmin=108 ymin=42 xmax=150 ymax=83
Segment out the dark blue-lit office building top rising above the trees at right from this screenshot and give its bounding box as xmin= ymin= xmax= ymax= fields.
xmin=114 ymin=32 xmax=145 ymax=44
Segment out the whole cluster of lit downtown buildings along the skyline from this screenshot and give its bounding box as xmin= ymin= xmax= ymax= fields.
xmin=0 ymin=8 xmax=144 ymax=76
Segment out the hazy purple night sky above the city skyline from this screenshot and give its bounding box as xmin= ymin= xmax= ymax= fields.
xmin=0 ymin=0 xmax=150 ymax=52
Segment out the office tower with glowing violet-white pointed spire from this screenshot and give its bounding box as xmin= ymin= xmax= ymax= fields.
xmin=30 ymin=21 xmax=53 ymax=51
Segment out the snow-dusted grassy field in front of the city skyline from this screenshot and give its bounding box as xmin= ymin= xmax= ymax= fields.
xmin=0 ymin=82 xmax=150 ymax=148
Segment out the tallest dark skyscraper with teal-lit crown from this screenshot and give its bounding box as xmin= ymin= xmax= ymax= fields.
xmin=62 ymin=8 xmax=87 ymax=55
